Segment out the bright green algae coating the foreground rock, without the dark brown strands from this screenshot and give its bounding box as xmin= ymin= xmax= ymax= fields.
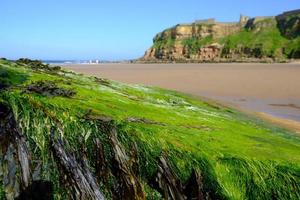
xmin=0 ymin=61 xmax=300 ymax=199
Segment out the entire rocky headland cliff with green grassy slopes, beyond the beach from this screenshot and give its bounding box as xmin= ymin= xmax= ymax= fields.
xmin=141 ymin=10 xmax=300 ymax=62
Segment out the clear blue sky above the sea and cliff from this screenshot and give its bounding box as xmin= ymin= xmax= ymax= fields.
xmin=0 ymin=0 xmax=300 ymax=60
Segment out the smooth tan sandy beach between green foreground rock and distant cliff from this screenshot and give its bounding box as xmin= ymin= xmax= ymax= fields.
xmin=65 ymin=63 xmax=300 ymax=133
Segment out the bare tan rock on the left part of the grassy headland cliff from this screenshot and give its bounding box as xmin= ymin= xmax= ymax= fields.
xmin=142 ymin=21 xmax=243 ymax=61
